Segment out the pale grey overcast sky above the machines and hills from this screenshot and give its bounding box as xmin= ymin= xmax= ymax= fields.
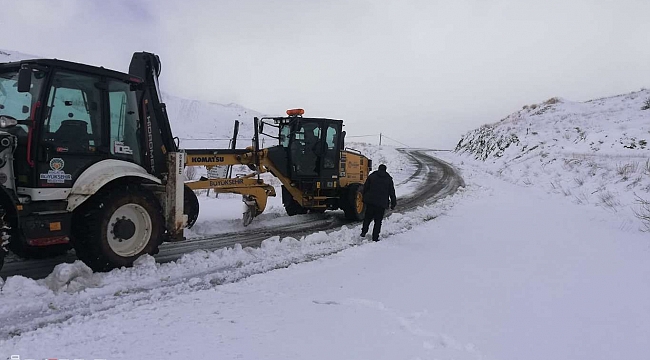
xmin=0 ymin=0 xmax=650 ymax=148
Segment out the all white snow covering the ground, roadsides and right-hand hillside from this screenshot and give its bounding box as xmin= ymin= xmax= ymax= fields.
xmin=0 ymin=50 xmax=650 ymax=360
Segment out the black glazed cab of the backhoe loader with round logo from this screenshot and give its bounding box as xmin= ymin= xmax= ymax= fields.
xmin=0 ymin=59 xmax=144 ymax=195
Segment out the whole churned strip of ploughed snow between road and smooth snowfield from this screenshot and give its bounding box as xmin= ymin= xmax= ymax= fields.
xmin=0 ymin=189 xmax=462 ymax=337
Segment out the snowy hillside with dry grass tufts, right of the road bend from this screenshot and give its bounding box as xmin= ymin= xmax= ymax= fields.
xmin=456 ymin=90 xmax=650 ymax=229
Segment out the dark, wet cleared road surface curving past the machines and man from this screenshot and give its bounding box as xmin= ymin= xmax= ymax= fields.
xmin=0 ymin=149 xmax=462 ymax=279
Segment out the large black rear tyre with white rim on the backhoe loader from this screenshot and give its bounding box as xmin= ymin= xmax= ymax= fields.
xmin=72 ymin=185 xmax=164 ymax=271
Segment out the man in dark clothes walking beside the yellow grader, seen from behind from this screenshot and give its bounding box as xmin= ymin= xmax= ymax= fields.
xmin=361 ymin=164 xmax=397 ymax=241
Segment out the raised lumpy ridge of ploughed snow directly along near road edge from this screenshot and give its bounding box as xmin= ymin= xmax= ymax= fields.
xmin=0 ymin=195 xmax=450 ymax=296
